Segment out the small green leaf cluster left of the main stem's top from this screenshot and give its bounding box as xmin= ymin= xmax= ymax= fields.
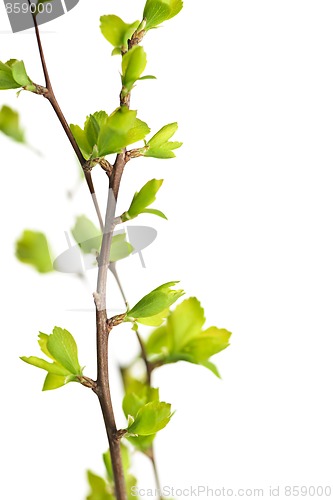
xmin=101 ymin=15 xmax=140 ymax=54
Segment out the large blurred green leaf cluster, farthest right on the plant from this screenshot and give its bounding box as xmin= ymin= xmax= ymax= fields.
xmin=145 ymin=297 xmax=231 ymax=377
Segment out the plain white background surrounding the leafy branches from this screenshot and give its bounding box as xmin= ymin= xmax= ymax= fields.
xmin=0 ymin=0 xmax=333 ymax=500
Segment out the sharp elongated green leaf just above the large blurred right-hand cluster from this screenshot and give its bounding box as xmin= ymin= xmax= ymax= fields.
xmin=126 ymin=281 xmax=184 ymax=321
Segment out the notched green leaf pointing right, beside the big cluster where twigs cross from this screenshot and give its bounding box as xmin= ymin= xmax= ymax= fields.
xmin=142 ymin=123 xmax=183 ymax=159
